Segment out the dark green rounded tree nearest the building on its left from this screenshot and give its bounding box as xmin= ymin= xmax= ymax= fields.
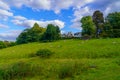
xmin=42 ymin=24 xmax=60 ymax=41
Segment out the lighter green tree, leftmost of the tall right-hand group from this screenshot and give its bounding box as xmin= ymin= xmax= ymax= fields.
xmin=81 ymin=16 xmax=95 ymax=36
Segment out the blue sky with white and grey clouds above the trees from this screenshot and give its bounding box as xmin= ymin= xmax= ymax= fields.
xmin=0 ymin=0 xmax=120 ymax=41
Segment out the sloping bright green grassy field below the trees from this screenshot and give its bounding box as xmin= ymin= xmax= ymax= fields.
xmin=0 ymin=38 xmax=120 ymax=80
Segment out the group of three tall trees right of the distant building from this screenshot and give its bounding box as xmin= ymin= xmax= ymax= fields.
xmin=80 ymin=10 xmax=120 ymax=38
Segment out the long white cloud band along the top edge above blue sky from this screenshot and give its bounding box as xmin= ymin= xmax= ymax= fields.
xmin=4 ymin=0 xmax=94 ymax=13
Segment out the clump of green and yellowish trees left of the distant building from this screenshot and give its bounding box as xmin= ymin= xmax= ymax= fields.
xmin=16 ymin=23 xmax=60 ymax=44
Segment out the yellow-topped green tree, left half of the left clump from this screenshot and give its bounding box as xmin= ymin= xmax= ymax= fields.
xmin=16 ymin=23 xmax=45 ymax=44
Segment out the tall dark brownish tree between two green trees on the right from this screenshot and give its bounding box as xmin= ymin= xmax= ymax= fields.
xmin=92 ymin=10 xmax=104 ymax=38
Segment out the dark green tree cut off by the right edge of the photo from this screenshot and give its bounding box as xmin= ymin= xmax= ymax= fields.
xmin=106 ymin=12 xmax=120 ymax=37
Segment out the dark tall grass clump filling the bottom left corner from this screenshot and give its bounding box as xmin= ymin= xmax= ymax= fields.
xmin=0 ymin=62 xmax=41 ymax=80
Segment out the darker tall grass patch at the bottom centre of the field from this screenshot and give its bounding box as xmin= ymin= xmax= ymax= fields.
xmin=57 ymin=61 xmax=88 ymax=79
